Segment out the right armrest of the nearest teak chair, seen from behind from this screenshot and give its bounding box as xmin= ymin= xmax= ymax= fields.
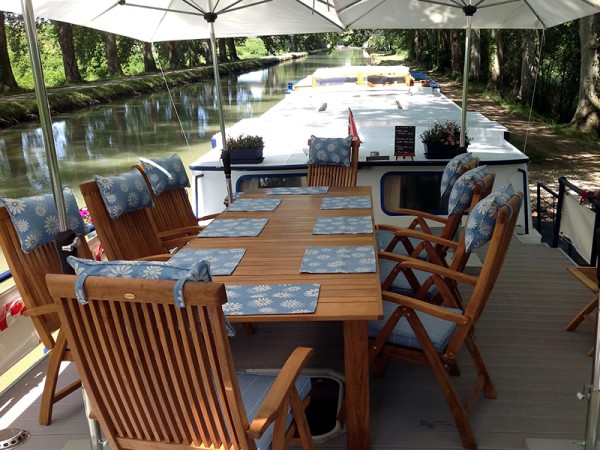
xmin=248 ymin=347 xmax=314 ymax=439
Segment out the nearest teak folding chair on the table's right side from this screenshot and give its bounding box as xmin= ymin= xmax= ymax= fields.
xmin=369 ymin=193 xmax=522 ymax=449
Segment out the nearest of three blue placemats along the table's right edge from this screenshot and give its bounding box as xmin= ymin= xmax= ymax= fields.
xmin=300 ymin=245 xmax=376 ymax=273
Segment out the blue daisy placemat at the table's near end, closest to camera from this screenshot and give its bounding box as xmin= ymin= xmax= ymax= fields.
xmin=223 ymin=284 xmax=321 ymax=316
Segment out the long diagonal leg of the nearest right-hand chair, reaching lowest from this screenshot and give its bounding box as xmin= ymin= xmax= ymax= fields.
xmin=403 ymin=308 xmax=477 ymax=450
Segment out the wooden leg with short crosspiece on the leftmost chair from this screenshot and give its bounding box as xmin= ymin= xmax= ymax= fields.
xmin=40 ymin=331 xmax=81 ymax=425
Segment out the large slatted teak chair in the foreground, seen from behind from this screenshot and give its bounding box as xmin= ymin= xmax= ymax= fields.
xmin=47 ymin=275 xmax=313 ymax=450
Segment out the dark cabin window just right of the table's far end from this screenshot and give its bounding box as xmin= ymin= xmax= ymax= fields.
xmin=381 ymin=172 xmax=448 ymax=215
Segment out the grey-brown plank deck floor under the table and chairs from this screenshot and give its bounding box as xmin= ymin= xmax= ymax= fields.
xmin=0 ymin=238 xmax=595 ymax=450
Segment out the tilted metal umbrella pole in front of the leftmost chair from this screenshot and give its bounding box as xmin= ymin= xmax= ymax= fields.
xmin=21 ymin=0 xmax=68 ymax=231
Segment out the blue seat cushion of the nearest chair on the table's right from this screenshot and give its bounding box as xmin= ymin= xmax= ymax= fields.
xmin=368 ymin=301 xmax=462 ymax=352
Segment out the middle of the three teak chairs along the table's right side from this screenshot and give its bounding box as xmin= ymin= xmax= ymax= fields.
xmin=375 ymin=157 xmax=482 ymax=261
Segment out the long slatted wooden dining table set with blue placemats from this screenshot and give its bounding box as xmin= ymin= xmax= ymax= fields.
xmin=188 ymin=186 xmax=383 ymax=449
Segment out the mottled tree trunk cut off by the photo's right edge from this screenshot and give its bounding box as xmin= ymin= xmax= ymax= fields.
xmin=571 ymin=14 xmax=600 ymax=134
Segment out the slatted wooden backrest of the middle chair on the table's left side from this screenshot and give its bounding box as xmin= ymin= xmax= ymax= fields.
xmin=79 ymin=181 xmax=167 ymax=260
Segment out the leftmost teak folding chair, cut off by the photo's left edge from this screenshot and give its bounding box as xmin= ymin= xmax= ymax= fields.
xmin=0 ymin=206 xmax=92 ymax=425
